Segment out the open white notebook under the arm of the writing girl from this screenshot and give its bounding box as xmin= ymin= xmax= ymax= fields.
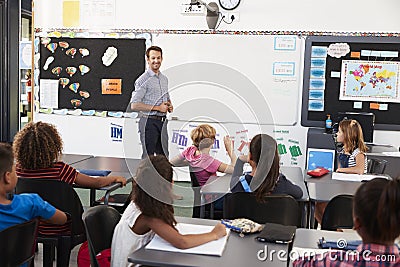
xmin=146 ymin=223 xmax=229 ymax=256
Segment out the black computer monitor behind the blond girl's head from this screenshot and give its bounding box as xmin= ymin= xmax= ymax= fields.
xmin=335 ymin=112 xmax=375 ymax=143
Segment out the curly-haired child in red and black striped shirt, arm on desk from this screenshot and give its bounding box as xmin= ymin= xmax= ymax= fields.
xmin=13 ymin=121 xmax=126 ymax=188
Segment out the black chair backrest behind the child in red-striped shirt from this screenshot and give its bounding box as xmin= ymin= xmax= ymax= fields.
xmin=16 ymin=178 xmax=85 ymax=235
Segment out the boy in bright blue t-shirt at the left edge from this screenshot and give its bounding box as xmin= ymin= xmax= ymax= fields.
xmin=0 ymin=143 xmax=67 ymax=233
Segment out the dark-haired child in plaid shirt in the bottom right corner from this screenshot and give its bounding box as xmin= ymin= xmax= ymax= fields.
xmin=293 ymin=178 xmax=400 ymax=267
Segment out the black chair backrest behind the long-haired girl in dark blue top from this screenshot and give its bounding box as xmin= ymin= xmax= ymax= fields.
xmin=224 ymin=192 xmax=301 ymax=226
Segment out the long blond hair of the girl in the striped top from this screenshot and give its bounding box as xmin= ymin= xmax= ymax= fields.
xmin=339 ymin=120 xmax=368 ymax=153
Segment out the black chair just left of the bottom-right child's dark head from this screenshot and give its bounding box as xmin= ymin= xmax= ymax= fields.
xmin=321 ymin=195 xmax=353 ymax=231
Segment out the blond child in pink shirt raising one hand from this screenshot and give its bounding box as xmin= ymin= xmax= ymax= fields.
xmin=171 ymin=124 xmax=236 ymax=186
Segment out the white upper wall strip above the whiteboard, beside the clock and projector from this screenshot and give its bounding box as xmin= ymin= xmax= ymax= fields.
xmin=34 ymin=0 xmax=400 ymax=32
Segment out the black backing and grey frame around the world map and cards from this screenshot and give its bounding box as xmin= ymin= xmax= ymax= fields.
xmin=301 ymin=36 xmax=400 ymax=130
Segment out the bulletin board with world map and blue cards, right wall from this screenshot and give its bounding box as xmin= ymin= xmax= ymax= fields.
xmin=301 ymin=36 xmax=400 ymax=130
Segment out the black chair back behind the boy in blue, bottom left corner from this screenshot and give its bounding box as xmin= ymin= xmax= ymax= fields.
xmin=0 ymin=219 xmax=39 ymax=267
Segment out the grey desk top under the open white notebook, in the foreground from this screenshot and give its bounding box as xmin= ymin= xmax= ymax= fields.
xmin=128 ymin=217 xmax=289 ymax=267
